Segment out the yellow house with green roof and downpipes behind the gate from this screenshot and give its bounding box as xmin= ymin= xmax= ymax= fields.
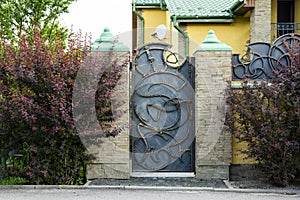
xmin=132 ymin=0 xmax=300 ymax=55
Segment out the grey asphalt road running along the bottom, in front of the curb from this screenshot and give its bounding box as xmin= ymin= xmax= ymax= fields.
xmin=0 ymin=189 xmax=300 ymax=200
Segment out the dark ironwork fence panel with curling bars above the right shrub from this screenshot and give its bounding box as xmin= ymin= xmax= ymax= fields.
xmin=232 ymin=34 xmax=300 ymax=80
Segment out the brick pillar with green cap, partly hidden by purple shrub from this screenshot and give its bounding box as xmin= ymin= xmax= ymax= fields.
xmin=85 ymin=29 xmax=130 ymax=179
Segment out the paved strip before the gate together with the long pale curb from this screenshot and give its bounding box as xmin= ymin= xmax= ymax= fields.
xmin=0 ymin=178 xmax=300 ymax=197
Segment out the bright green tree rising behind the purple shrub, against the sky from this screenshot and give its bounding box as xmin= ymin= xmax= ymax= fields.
xmin=0 ymin=0 xmax=76 ymax=41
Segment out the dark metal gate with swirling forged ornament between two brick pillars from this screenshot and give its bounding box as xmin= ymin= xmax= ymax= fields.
xmin=131 ymin=43 xmax=195 ymax=172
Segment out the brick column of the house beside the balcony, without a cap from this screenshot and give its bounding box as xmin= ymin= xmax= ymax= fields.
xmin=250 ymin=0 xmax=271 ymax=43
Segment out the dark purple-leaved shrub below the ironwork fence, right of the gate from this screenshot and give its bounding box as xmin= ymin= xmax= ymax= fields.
xmin=226 ymin=39 xmax=300 ymax=186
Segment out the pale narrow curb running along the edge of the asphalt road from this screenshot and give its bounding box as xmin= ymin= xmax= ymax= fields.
xmin=0 ymin=185 xmax=300 ymax=195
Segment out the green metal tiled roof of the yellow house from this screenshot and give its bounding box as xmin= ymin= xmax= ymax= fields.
xmin=133 ymin=0 xmax=245 ymax=19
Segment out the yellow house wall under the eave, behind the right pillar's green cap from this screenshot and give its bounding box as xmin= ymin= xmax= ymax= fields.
xmin=187 ymin=14 xmax=250 ymax=54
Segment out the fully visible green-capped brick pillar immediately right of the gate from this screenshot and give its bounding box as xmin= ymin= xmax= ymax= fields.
xmin=194 ymin=30 xmax=232 ymax=179
